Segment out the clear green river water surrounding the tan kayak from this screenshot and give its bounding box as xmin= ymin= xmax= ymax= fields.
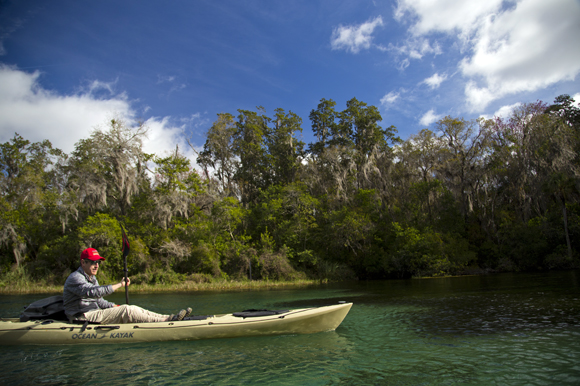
xmin=0 ymin=271 xmax=580 ymax=386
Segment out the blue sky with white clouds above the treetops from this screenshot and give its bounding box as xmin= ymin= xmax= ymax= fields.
xmin=0 ymin=0 xmax=580 ymax=159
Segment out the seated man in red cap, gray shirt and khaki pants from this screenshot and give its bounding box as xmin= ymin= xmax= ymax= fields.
xmin=63 ymin=248 xmax=191 ymax=324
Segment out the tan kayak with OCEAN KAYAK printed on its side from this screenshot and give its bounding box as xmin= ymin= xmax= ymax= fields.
xmin=0 ymin=303 xmax=352 ymax=345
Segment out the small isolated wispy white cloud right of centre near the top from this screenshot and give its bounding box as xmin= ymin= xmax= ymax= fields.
xmin=330 ymin=16 xmax=383 ymax=54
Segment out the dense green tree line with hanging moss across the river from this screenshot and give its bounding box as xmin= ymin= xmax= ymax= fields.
xmin=0 ymin=95 xmax=580 ymax=285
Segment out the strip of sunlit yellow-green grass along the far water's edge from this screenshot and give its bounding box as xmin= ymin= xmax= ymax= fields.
xmin=0 ymin=280 xmax=328 ymax=295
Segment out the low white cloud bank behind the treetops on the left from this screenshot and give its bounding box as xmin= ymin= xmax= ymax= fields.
xmin=0 ymin=66 xmax=199 ymax=163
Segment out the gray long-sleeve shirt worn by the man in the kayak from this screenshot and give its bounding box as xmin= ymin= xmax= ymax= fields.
xmin=62 ymin=267 xmax=115 ymax=319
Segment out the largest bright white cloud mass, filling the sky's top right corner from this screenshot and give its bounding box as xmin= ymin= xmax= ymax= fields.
xmin=395 ymin=0 xmax=580 ymax=111
